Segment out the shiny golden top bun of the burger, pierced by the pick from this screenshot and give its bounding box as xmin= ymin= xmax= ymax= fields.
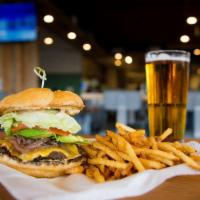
xmin=0 ymin=88 xmax=84 ymax=115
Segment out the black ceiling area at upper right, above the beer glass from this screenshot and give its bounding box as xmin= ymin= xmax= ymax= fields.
xmin=51 ymin=0 xmax=200 ymax=53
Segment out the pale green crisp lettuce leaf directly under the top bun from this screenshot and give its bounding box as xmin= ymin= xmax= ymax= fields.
xmin=0 ymin=110 xmax=81 ymax=134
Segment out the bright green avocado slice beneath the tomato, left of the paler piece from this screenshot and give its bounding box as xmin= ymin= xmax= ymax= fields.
xmin=15 ymin=129 xmax=54 ymax=139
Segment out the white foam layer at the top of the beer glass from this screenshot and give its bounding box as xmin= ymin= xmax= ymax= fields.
xmin=145 ymin=51 xmax=190 ymax=62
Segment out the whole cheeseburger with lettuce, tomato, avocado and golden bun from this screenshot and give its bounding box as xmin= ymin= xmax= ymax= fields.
xmin=0 ymin=88 xmax=87 ymax=177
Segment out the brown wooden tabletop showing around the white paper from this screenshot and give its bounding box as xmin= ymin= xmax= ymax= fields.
xmin=0 ymin=140 xmax=200 ymax=200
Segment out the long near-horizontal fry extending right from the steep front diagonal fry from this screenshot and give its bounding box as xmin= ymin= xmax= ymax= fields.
xmin=133 ymin=147 xmax=179 ymax=161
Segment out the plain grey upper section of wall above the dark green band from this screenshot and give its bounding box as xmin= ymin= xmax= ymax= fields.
xmin=39 ymin=29 xmax=82 ymax=73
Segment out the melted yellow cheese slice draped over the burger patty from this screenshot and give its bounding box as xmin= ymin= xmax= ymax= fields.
xmin=0 ymin=140 xmax=80 ymax=162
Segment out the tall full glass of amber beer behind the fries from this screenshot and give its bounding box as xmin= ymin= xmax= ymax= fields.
xmin=145 ymin=50 xmax=190 ymax=141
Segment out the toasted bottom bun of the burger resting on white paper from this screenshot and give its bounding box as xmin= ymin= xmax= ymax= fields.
xmin=0 ymin=155 xmax=82 ymax=178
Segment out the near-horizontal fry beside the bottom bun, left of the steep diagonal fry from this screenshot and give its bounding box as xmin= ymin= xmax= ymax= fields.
xmin=88 ymin=158 xmax=128 ymax=169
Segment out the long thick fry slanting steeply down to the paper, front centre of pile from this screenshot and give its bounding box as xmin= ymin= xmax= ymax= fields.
xmin=107 ymin=131 xmax=145 ymax=172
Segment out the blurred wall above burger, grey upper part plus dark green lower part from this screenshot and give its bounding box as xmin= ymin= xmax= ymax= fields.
xmin=39 ymin=29 xmax=82 ymax=93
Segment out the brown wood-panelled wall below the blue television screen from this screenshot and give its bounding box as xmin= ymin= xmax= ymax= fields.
xmin=0 ymin=42 xmax=38 ymax=93
